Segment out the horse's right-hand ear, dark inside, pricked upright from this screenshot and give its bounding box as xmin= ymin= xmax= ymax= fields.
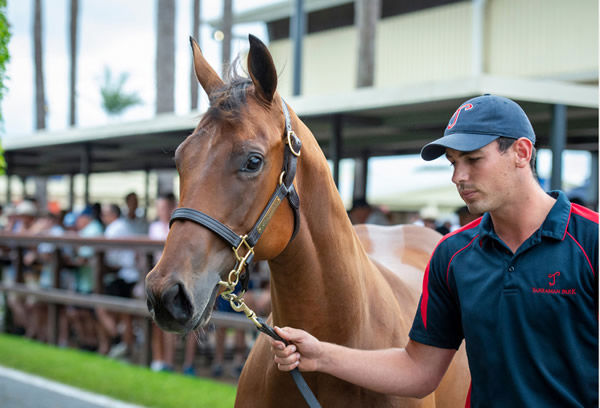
xmin=248 ymin=34 xmax=277 ymax=103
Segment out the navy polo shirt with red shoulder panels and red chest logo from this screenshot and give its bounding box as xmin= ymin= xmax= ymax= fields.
xmin=410 ymin=192 xmax=598 ymax=407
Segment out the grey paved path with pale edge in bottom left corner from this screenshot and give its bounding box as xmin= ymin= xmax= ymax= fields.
xmin=0 ymin=366 xmax=143 ymax=408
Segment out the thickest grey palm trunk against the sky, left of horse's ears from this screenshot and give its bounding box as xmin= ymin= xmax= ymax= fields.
xmin=156 ymin=0 xmax=175 ymax=113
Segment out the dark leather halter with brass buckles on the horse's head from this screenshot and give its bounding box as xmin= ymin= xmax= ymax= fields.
xmin=169 ymin=98 xmax=302 ymax=290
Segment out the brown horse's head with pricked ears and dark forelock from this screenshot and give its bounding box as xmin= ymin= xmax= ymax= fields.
xmin=146 ymin=36 xmax=297 ymax=333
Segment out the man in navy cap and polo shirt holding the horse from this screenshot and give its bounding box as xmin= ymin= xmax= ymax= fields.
xmin=272 ymin=95 xmax=598 ymax=407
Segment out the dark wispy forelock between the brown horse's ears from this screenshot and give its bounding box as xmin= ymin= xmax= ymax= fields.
xmin=206 ymin=58 xmax=252 ymax=122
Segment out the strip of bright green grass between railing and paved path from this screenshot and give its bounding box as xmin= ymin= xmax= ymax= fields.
xmin=0 ymin=334 xmax=235 ymax=408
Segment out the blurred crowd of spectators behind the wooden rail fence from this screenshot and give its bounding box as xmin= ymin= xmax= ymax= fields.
xmin=0 ymin=193 xmax=270 ymax=377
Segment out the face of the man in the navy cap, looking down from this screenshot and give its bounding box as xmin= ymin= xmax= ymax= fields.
xmin=446 ymin=142 xmax=517 ymax=214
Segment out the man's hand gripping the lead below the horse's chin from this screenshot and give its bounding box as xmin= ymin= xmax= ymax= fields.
xmin=271 ymin=327 xmax=321 ymax=371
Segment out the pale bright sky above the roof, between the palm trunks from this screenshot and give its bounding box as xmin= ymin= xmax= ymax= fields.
xmin=2 ymin=0 xmax=273 ymax=131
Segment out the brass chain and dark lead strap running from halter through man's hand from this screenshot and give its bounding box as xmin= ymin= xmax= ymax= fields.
xmin=219 ymin=235 xmax=321 ymax=408
